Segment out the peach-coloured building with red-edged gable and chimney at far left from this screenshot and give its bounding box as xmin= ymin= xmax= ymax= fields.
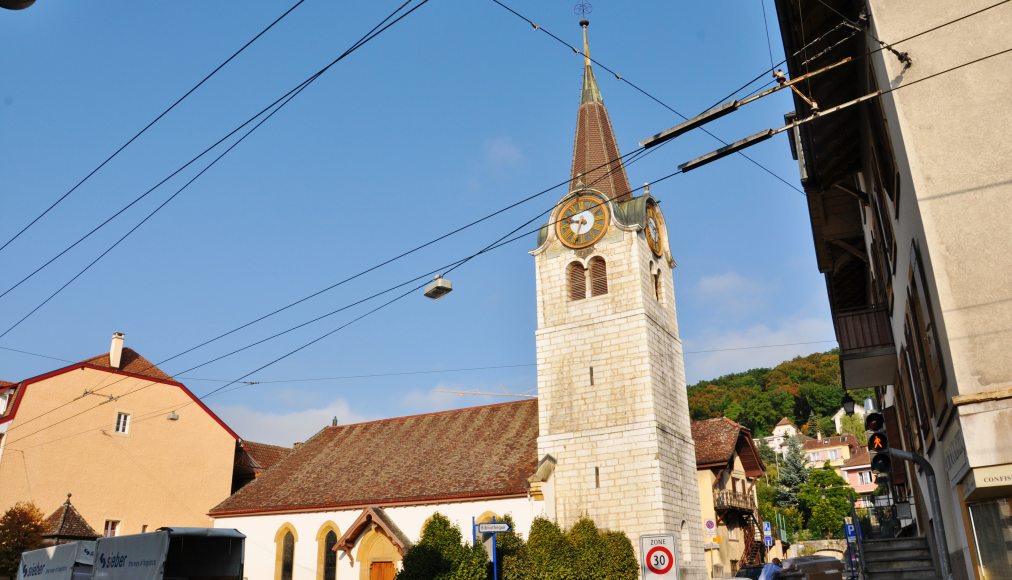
xmin=0 ymin=333 xmax=238 ymax=534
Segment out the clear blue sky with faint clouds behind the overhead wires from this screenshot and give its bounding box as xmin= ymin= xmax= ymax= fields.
xmin=0 ymin=0 xmax=834 ymax=443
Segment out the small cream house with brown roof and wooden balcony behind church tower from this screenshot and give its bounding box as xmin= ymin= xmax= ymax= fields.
xmin=692 ymin=417 xmax=766 ymax=578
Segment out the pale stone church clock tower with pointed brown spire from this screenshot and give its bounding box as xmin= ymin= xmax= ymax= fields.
xmin=531 ymin=20 xmax=705 ymax=578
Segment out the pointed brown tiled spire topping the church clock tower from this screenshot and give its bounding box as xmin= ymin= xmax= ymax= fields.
xmin=570 ymin=20 xmax=631 ymax=201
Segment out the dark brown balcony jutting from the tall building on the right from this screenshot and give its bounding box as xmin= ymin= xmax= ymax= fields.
xmin=836 ymin=306 xmax=897 ymax=389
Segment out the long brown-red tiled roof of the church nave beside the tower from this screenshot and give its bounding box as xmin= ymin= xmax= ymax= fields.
xmin=210 ymin=400 xmax=537 ymax=517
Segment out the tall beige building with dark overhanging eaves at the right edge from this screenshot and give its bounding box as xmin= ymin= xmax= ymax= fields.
xmin=775 ymin=0 xmax=1012 ymax=579
